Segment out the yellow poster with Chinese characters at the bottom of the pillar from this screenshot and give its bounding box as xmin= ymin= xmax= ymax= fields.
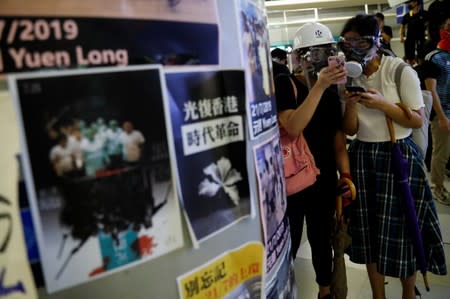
xmin=177 ymin=242 xmax=268 ymax=299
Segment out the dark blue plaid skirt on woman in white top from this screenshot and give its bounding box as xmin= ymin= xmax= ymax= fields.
xmin=347 ymin=137 xmax=447 ymax=278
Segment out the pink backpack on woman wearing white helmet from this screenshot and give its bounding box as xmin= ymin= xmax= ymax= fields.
xmin=278 ymin=75 xmax=320 ymax=195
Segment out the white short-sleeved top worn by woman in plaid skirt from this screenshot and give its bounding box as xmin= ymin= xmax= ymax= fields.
xmin=353 ymin=56 xmax=424 ymax=142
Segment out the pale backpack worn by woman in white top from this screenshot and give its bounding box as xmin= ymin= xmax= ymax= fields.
xmin=395 ymin=62 xmax=433 ymax=157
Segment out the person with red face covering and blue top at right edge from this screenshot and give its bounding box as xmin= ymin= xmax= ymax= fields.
xmin=425 ymin=17 xmax=450 ymax=205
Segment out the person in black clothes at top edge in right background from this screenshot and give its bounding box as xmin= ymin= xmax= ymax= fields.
xmin=400 ymin=0 xmax=428 ymax=66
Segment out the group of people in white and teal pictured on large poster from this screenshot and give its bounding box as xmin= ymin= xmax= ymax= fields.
xmin=49 ymin=118 xmax=145 ymax=177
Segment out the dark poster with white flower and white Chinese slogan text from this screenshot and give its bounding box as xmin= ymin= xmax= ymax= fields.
xmin=166 ymin=67 xmax=251 ymax=245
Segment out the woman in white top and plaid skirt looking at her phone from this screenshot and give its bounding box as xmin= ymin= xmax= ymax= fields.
xmin=338 ymin=15 xmax=447 ymax=299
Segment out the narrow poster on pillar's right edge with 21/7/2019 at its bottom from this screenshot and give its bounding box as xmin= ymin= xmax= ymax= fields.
xmin=235 ymin=0 xmax=277 ymax=139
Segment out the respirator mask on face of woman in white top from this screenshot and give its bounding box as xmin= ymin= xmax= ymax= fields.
xmin=338 ymin=36 xmax=379 ymax=78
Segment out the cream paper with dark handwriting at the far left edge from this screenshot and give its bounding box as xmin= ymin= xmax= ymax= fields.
xmin=0 ymin=92 xmax=37 ymax=299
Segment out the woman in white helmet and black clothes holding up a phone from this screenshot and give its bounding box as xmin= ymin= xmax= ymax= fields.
xmin=275 ymin=23 xmax=350 ymax=298
